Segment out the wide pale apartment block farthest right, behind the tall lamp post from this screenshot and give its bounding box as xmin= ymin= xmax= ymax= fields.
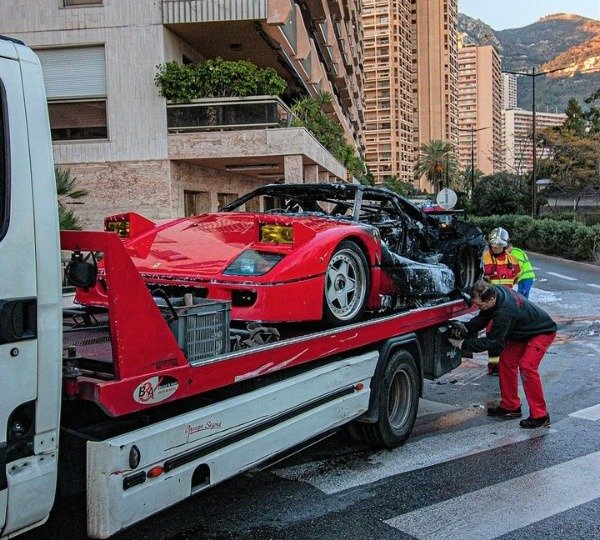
xmin=503 ymin=109 xmax=567 ymax=174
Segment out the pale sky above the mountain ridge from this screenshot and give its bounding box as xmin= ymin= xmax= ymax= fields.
xmin=458 ymin=0 xmax=600 ymax=30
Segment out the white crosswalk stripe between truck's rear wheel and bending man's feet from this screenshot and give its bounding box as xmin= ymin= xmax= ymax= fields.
xmin=275 ymin=419 xmax=552 ymax=494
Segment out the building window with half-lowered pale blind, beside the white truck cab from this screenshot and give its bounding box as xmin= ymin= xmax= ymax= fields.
xmin=37 ymin=46 xmax=108 ymax=141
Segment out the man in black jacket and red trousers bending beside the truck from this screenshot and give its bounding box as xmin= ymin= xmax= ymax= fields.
xmin=450 ymin=280 xmax=557 ymax=429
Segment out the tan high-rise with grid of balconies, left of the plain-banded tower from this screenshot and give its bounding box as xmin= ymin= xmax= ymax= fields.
xmin=362 ymin=0 xmax=414 ymax=182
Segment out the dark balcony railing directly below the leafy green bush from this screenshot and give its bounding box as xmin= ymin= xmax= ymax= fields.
xmin=167 ymin=96 xmax=293 ymax=133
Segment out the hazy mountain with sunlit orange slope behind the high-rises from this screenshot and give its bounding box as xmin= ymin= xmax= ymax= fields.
xmin=459 ymin=13 xmax=600 ymax=112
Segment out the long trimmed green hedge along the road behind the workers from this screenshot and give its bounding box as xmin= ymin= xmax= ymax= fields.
xmin=469 ymin=214 xmax=600 ymax=264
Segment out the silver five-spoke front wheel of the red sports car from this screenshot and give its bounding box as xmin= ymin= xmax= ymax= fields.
xmin=323 ymin=240 xmax=369 ymax=326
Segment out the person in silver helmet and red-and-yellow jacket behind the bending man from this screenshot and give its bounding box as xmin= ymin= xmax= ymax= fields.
xmin=483 ymin=227 xmax=521 ymax=375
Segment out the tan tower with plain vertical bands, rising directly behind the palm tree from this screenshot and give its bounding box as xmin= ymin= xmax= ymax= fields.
xmin=411 ymin=0 xmax=458 ymax=191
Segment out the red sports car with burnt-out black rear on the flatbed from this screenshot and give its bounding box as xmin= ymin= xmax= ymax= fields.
xmin=76 ymin=184 xmax=485 ymax=325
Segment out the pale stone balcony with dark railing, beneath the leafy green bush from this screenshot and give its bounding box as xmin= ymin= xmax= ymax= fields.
xmin=167 ymin=96 xmax=346 ymax=187
